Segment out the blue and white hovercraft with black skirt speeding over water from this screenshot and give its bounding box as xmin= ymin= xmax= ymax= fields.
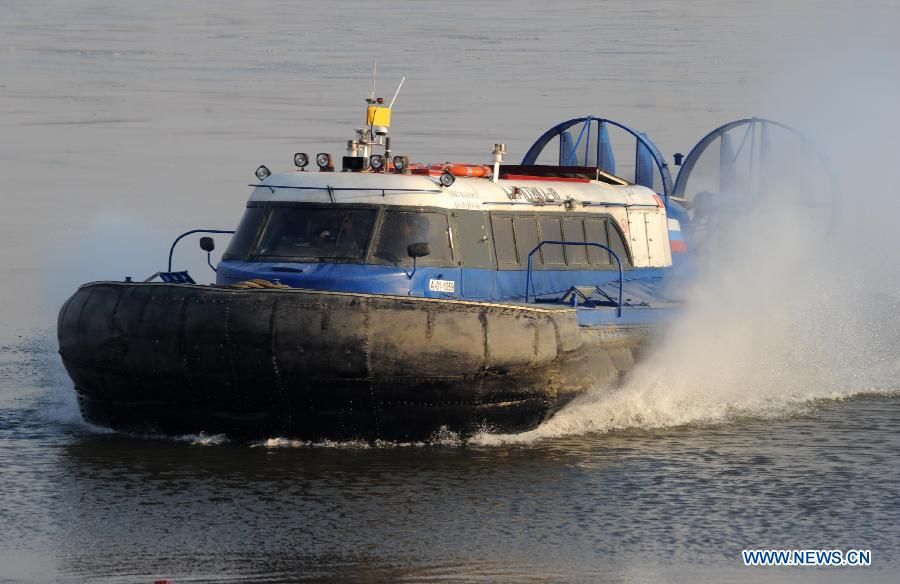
xmin=59 ymin=85 xmax=800 ymax=440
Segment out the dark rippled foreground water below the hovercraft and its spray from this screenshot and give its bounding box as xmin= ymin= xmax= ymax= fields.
xmin=0 ymin=340 xmax=900 ymax=582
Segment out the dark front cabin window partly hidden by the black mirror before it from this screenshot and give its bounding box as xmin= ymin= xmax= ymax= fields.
xmin=374 ymin=211 xmax=453 ymax=263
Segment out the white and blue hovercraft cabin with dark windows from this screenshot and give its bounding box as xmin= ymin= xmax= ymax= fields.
xmin=217 ymin=171 xmax=672 ymax=301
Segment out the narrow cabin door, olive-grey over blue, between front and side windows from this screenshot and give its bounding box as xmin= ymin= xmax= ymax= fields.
xmin=453 ymin=209 xmax=495 ymax=299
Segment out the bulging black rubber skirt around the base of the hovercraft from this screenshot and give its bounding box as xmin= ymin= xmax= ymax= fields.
xmin=58 ymin=282 xmax=650 ymax=441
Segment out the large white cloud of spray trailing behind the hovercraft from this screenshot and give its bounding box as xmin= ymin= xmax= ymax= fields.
xmin=475 ymin=30 xmax=900 ymax=444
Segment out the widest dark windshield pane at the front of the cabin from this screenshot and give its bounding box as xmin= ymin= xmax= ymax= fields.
xmin=255 ymin=207 xmax=376 ymax=259
